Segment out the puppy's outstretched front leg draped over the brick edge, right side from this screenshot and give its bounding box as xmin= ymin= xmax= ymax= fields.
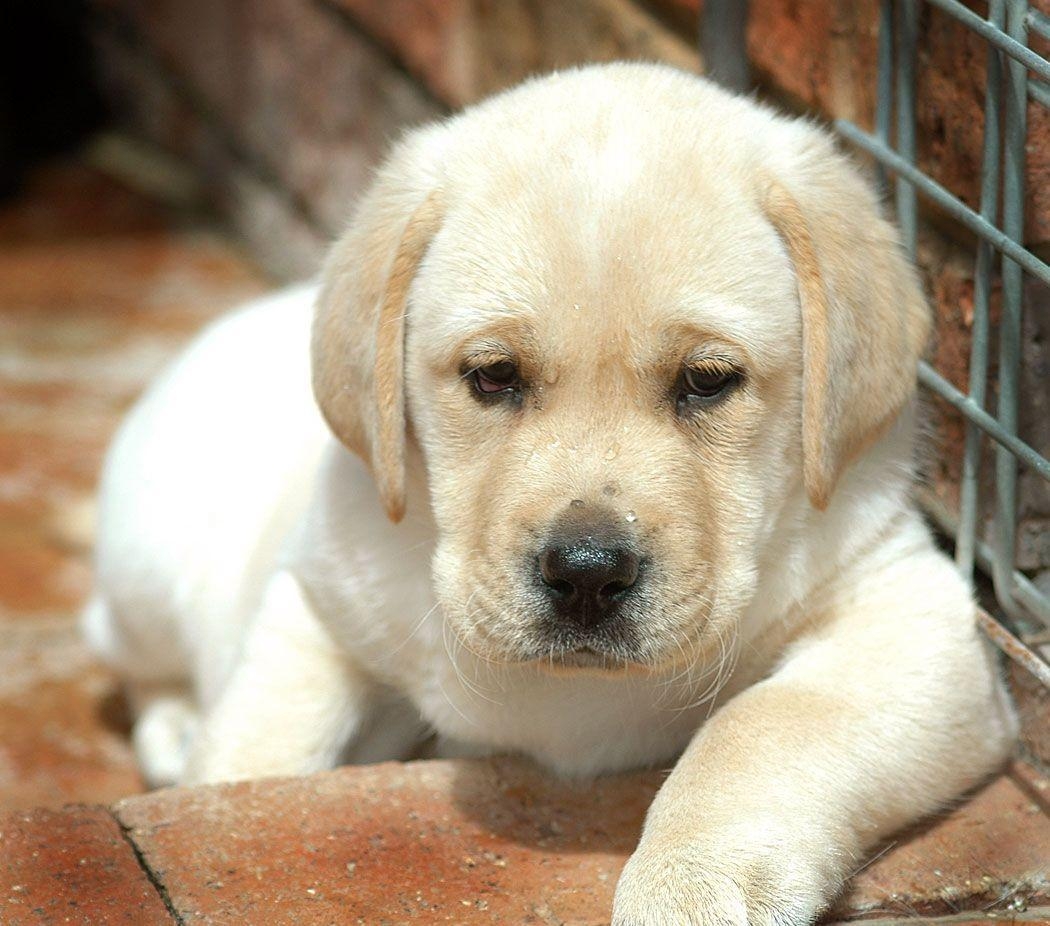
xmin=613 ymin=554 xmax=1014 ymax=926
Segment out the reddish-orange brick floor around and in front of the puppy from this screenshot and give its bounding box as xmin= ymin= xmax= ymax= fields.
xmin=0 ymin=158 xmax=1050 ymax=926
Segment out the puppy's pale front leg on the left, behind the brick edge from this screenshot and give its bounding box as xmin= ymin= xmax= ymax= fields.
xmin=183 ymin=571 xmax=382 ymax=784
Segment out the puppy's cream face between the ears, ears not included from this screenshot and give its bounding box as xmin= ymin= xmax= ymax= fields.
xmin=406 ymin=165 xmax=801 ymax=667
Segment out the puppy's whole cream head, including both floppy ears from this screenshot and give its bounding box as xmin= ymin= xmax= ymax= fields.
xmin=314 ymin=65 xmax=927 ymax=669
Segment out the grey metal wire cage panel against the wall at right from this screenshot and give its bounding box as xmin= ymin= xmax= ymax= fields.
xmin=701 ymin=0 xmax=1050 ymax=687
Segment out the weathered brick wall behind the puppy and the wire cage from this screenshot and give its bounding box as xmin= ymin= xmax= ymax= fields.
xmin=86 ymin=0 xmax=1050 ymax=592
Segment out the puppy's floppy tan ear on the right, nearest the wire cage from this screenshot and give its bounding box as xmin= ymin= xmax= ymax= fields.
xmin=764 ymin=139 xmax=929 ymax=509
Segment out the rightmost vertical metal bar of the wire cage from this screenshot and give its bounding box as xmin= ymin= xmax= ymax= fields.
xmin=992 ymin=0 xmax=1028 ymax=620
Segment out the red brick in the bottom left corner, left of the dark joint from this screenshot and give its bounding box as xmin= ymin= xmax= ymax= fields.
xmin=0 ymin=806 xmax=174 ymax=926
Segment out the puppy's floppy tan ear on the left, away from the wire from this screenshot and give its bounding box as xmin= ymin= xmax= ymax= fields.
xmin=312 ymin=130 xmax=442 ymax=522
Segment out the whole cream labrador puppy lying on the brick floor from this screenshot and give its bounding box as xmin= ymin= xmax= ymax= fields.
xmin=85 ymin=64 xmax=1014 ymax=924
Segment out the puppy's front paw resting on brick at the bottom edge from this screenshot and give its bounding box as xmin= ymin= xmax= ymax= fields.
xmin=612 ymin=840 xmax=831 ymax=926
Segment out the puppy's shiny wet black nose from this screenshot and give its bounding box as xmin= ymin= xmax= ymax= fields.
xmin=540 ymin=536 xmax=639 ymax=627
